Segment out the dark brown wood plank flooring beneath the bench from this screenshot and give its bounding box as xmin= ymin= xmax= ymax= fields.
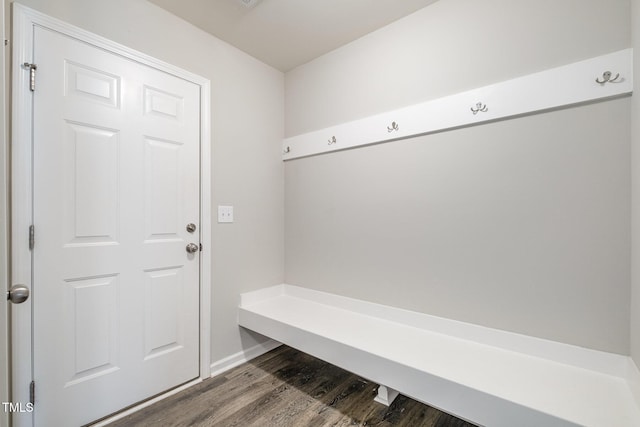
xmin=110 ymin=346 xmax=473 ymax=427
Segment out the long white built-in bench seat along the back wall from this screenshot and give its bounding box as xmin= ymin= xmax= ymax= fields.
xmin=239 ymin=285 xmax=640 ymax=427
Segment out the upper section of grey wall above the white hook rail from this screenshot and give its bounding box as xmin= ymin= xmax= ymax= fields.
xmin=285 ymin=0 xmax=630 ymax=136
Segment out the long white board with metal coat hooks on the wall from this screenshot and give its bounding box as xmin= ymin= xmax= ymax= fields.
xmin=282 ymin=49 xmax=633 ymax=160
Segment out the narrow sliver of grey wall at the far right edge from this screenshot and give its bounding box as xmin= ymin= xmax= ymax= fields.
xmin=631 ymin=0 xmax=640 ymax=367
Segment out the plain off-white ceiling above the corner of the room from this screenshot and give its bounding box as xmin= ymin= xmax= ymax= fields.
xmin=149 ymin=0 xmax=437 ymax=72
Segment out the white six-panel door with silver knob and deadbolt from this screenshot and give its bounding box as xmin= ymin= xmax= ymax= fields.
xmin=31 ymin=26 xmax=200 ymax=426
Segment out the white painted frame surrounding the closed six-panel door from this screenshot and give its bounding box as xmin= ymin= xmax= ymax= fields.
xmin=11 ymin=3 xmax=212 ymax=427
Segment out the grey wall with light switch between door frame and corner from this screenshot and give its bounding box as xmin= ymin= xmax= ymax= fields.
xmin=5 ymin=0 xmax=284 ymax=368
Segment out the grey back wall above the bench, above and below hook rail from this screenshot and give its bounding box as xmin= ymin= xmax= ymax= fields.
xmin=285 ymin=0 xmax=631 ymax=354
